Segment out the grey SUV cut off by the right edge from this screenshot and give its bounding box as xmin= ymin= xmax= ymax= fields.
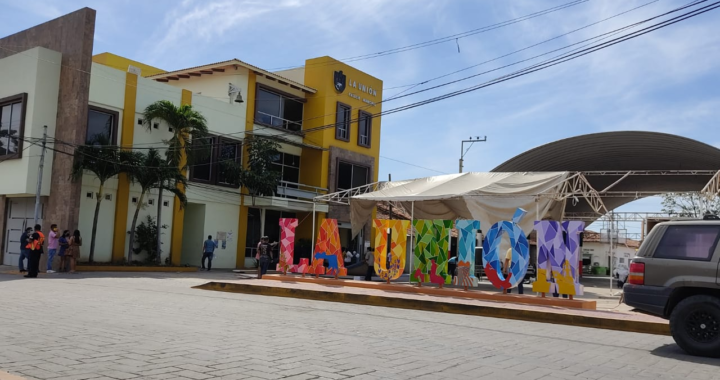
xmin=623 ymin=220 xmax=720 ymax=358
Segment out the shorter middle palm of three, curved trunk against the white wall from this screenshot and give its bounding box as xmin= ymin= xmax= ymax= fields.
xmin=127 ymin=149 xmax=187 ymax=262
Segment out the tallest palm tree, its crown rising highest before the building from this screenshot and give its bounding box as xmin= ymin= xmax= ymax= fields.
xmin=143 ymin=100 xmax=210 ymax=260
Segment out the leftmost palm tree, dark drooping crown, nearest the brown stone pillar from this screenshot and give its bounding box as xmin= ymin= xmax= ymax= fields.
xmin=70 ymin=135 xmax=131 ymax=263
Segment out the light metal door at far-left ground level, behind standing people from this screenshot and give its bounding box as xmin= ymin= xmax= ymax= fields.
xmin=3 ymin=198 xmax=43 ymax=266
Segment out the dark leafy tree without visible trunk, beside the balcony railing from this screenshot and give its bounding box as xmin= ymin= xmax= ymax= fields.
xmin=223 ymin=136 xmax=281 ymax=206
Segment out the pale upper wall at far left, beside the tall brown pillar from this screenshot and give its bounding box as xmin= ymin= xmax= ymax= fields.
xmin=0 ymin=48 xmax=60 ymax=196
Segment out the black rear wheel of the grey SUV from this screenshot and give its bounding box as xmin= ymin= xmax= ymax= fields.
xmin=670 ymin=296 xmax=720 ymax=358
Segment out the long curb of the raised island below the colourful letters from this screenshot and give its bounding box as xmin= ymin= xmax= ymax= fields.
xmin=193 ymin=282 xmax=670 ymax=335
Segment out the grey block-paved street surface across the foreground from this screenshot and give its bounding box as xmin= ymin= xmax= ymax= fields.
xmin=0 ymin=272 xmax=720 ymax=380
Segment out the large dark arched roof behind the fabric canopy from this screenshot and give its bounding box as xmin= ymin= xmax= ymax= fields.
xmin=492 ymin=131 xmax=720 ymax=212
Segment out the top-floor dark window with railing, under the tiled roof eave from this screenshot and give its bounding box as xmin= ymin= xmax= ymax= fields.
xmin=255 ymin=86 xmax=305 ymax=132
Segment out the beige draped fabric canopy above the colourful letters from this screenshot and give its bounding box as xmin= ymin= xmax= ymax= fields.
xmin=350 ymin=172 xmax=571 ymax=236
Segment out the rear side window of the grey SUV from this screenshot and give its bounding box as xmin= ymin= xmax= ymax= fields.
xmin=653 ymin=225 xmax=720 ymax=261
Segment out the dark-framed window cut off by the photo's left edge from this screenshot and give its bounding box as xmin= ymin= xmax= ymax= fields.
xmin=0 ymin=94 xmax=27 ymax=157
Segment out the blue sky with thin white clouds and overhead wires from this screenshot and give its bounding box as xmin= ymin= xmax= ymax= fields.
xmin=0 ymin=0 xmax=720 ymax=233
